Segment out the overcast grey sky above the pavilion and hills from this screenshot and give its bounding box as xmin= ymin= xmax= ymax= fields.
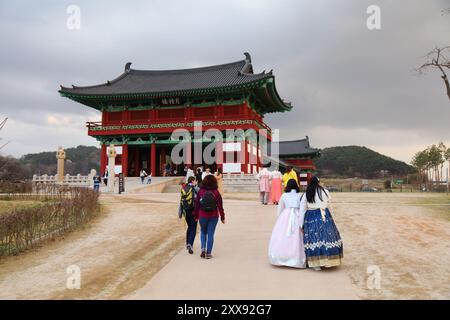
xmin=0 ymin=0 xmax=450 ymax=162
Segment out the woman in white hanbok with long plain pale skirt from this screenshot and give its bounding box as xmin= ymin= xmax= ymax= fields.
xmin=269 ymin=179 xmax=306 ymax=268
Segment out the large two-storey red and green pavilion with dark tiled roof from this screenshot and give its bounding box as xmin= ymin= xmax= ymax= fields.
xmin=59 ymin=53 xmax=318 ymax=176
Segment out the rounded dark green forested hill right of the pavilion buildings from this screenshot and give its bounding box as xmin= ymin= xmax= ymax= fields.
xmin=314 ymin=146 xmax=414 ymax=178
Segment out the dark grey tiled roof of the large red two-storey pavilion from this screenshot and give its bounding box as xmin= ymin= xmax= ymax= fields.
xmin=60 ymin=54 xmax=273 ymax=95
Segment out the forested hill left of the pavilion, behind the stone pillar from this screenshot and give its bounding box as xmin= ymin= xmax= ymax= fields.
xmin=19 ymin=146 xmax=100 ymax=175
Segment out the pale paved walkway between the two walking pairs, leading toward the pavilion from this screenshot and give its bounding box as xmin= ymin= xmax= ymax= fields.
xmin=129 ymin=195 xmax=357 ymax=300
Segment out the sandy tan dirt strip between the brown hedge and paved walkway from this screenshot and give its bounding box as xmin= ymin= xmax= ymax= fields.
xmin=0 ymin=195 xmax=184 ymax=299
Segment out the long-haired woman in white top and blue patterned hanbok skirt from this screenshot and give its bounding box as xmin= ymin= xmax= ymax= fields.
xmin=300 ymin=177 xmax=344 ymax=270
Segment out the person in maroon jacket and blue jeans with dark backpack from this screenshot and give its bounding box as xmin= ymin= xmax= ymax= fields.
xmin=194 ymin=174 xmax=225 ymax=259
